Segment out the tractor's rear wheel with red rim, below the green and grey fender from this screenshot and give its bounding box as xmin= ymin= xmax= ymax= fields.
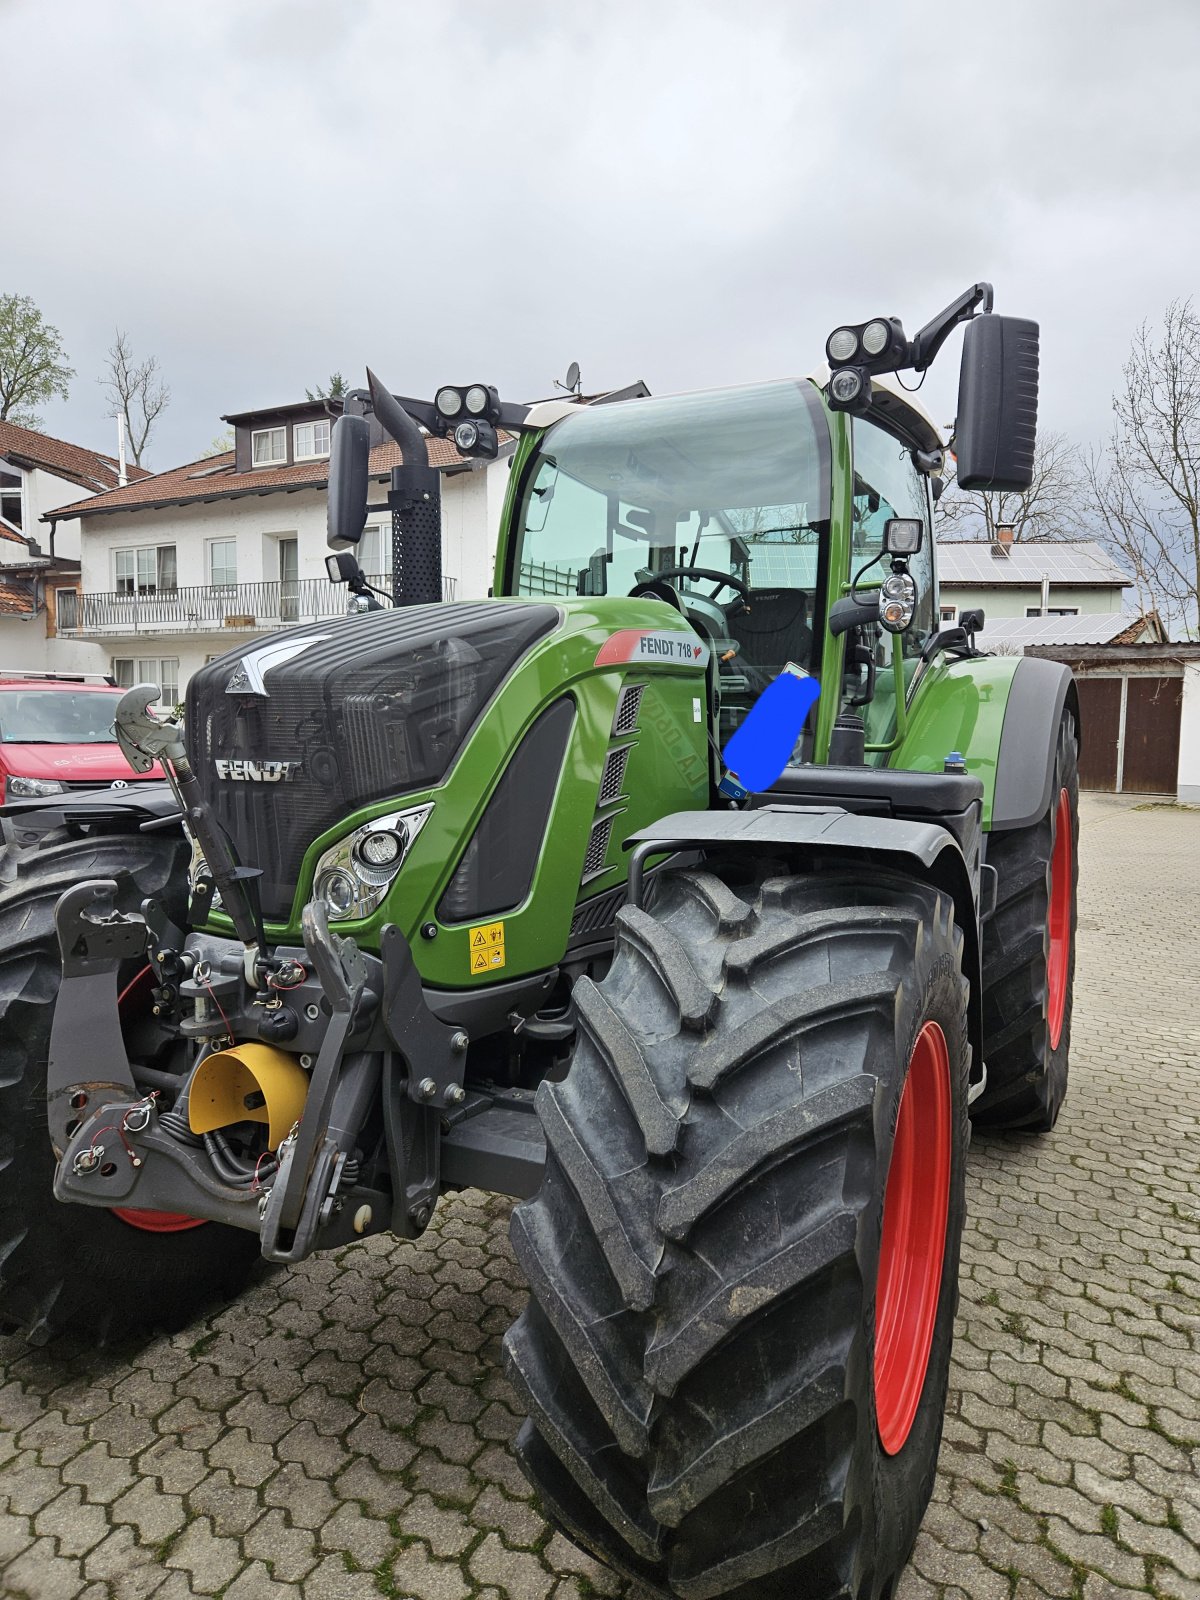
xmin=971 ymin=712 xmax=1078 ymax=1133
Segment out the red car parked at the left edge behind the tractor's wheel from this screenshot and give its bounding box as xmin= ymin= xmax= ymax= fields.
xmin=0 ymin=670 xmax=163 ymax=802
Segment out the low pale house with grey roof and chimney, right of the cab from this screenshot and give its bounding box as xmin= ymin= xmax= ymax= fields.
xmin=938 ymin=526 xmax=1166 ymax=653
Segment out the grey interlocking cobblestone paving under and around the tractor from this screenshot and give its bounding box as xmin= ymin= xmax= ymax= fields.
xmin=0 ymin=798 xmax=1200 ymax=1600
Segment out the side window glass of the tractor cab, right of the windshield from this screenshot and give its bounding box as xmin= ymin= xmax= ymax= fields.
xmin=850 ymin=416 xmax=938 ymax=677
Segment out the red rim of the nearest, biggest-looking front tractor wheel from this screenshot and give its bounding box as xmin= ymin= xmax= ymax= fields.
xmin=875 ymin=1022 xmax=952 ymax=1456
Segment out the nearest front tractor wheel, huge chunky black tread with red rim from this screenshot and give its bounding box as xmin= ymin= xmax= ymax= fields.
xmin=506 ymin=864 xmax=970 ymax=1600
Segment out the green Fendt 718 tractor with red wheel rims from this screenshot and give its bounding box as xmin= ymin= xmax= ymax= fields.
xmin=0 ymin=283 xmax=1078 ymax=1600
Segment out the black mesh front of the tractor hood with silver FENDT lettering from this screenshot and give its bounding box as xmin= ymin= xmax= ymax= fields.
xmin=186 ymin=602 xmax=558 ymax=920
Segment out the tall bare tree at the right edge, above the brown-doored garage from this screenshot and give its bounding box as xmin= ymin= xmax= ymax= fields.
xmin=1086 ymin=299 xmax=1200 ymax=629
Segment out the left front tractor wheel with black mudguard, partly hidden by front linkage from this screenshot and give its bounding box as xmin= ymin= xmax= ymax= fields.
xmin=0 ymin=834 xmax=259 ymax=1344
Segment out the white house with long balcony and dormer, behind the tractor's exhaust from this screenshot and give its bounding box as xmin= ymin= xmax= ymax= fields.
xmin=43 ymin=400 xmax=514 ymax=707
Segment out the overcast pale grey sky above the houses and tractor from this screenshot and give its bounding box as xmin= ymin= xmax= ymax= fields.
xmin=9 ymin=0 xmax=1200 ymax=469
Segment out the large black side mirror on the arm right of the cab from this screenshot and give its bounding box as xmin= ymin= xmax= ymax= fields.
xmin=954 ymin=315 xmax=1038 ymax=493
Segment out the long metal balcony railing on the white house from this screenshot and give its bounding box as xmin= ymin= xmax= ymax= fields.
xmin=58 ymin=578 xmax=458 ymax=637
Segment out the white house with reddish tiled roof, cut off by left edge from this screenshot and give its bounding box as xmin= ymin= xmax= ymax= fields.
xmin=0 ymin=422 xmax=149 ymax=672
